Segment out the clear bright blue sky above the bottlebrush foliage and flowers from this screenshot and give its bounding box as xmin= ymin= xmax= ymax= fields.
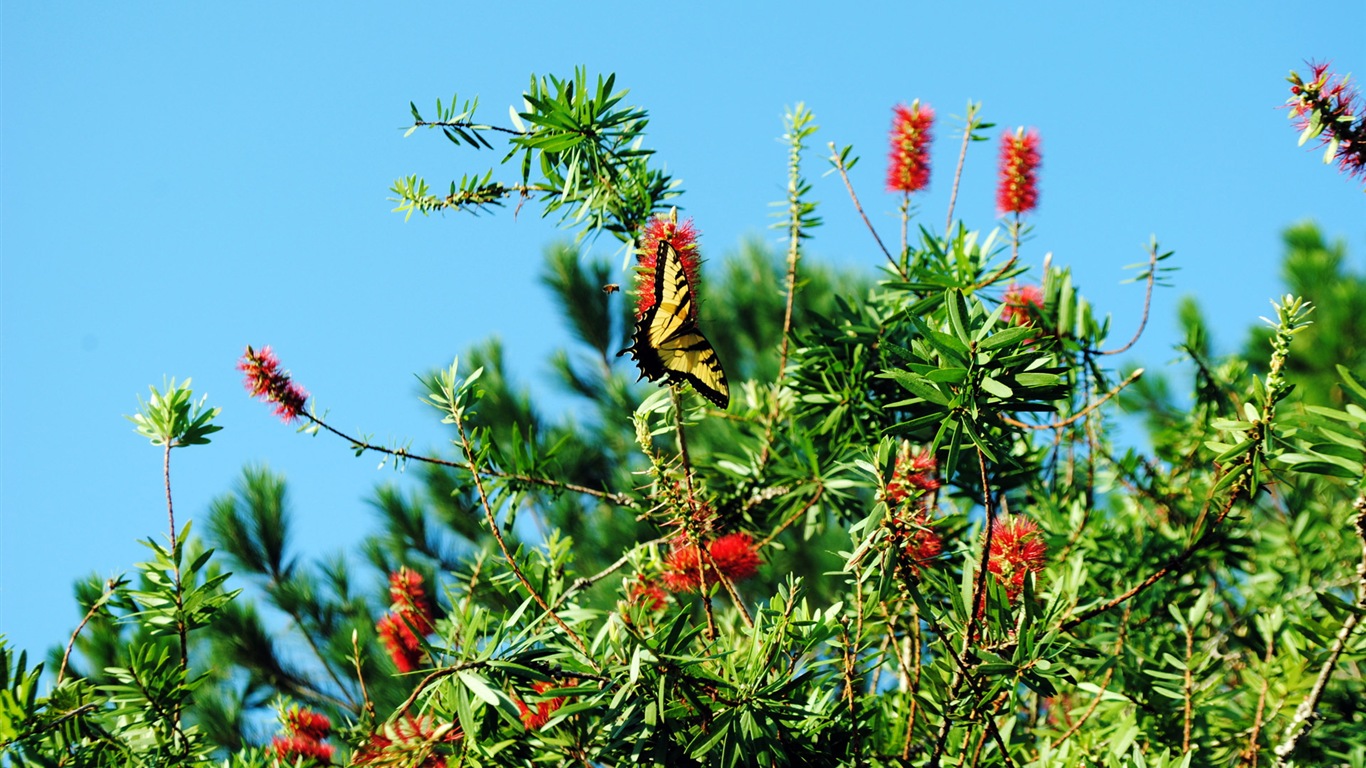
xmin=0 ymin=1 xmax=1366 ymax=652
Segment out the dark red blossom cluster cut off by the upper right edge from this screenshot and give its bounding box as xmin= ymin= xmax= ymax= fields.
xmin=1287 ymin=61 xmax=1366 ymax=179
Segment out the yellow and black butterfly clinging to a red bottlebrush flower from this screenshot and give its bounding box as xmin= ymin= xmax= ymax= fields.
xmin=616 ymin=239 xmax=731 ymax=410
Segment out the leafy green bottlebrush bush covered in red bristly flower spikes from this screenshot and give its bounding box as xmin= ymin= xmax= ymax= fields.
xmin=8 ymin=62 xmax=1366 ymax=767
